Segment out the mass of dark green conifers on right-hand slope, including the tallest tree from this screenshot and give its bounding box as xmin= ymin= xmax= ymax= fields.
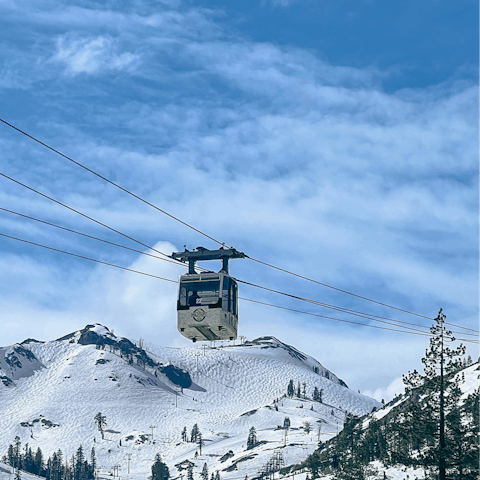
xmin=303 ymin=311 xmax=480 ymax=480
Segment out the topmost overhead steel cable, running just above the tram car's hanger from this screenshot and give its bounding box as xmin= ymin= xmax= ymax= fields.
xmin=0 ymin=118 xmax=442 ymax=320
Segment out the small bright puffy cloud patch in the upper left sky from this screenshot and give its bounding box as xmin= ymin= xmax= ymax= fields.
xmin=52 ymin=35 xmax=140 ymax=75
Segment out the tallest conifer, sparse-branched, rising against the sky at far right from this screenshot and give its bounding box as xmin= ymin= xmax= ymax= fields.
xmin=403 ymin=309 xmax=465 ymax=480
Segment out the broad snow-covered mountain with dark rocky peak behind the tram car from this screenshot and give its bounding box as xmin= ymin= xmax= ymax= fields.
xmin=0 ymin=324 xmax=381 ymax=479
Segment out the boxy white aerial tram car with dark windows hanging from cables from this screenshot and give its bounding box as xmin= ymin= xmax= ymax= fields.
xmin=172 ymin=247 xmax=245 ymax=342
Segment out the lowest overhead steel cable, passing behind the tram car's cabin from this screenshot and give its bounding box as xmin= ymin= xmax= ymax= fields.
xmin=0 ymin=233 xmax=480 ymax=344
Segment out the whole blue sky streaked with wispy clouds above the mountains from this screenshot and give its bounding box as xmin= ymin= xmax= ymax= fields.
xmin=0 ymin=0 xmax=479 ymax=397
